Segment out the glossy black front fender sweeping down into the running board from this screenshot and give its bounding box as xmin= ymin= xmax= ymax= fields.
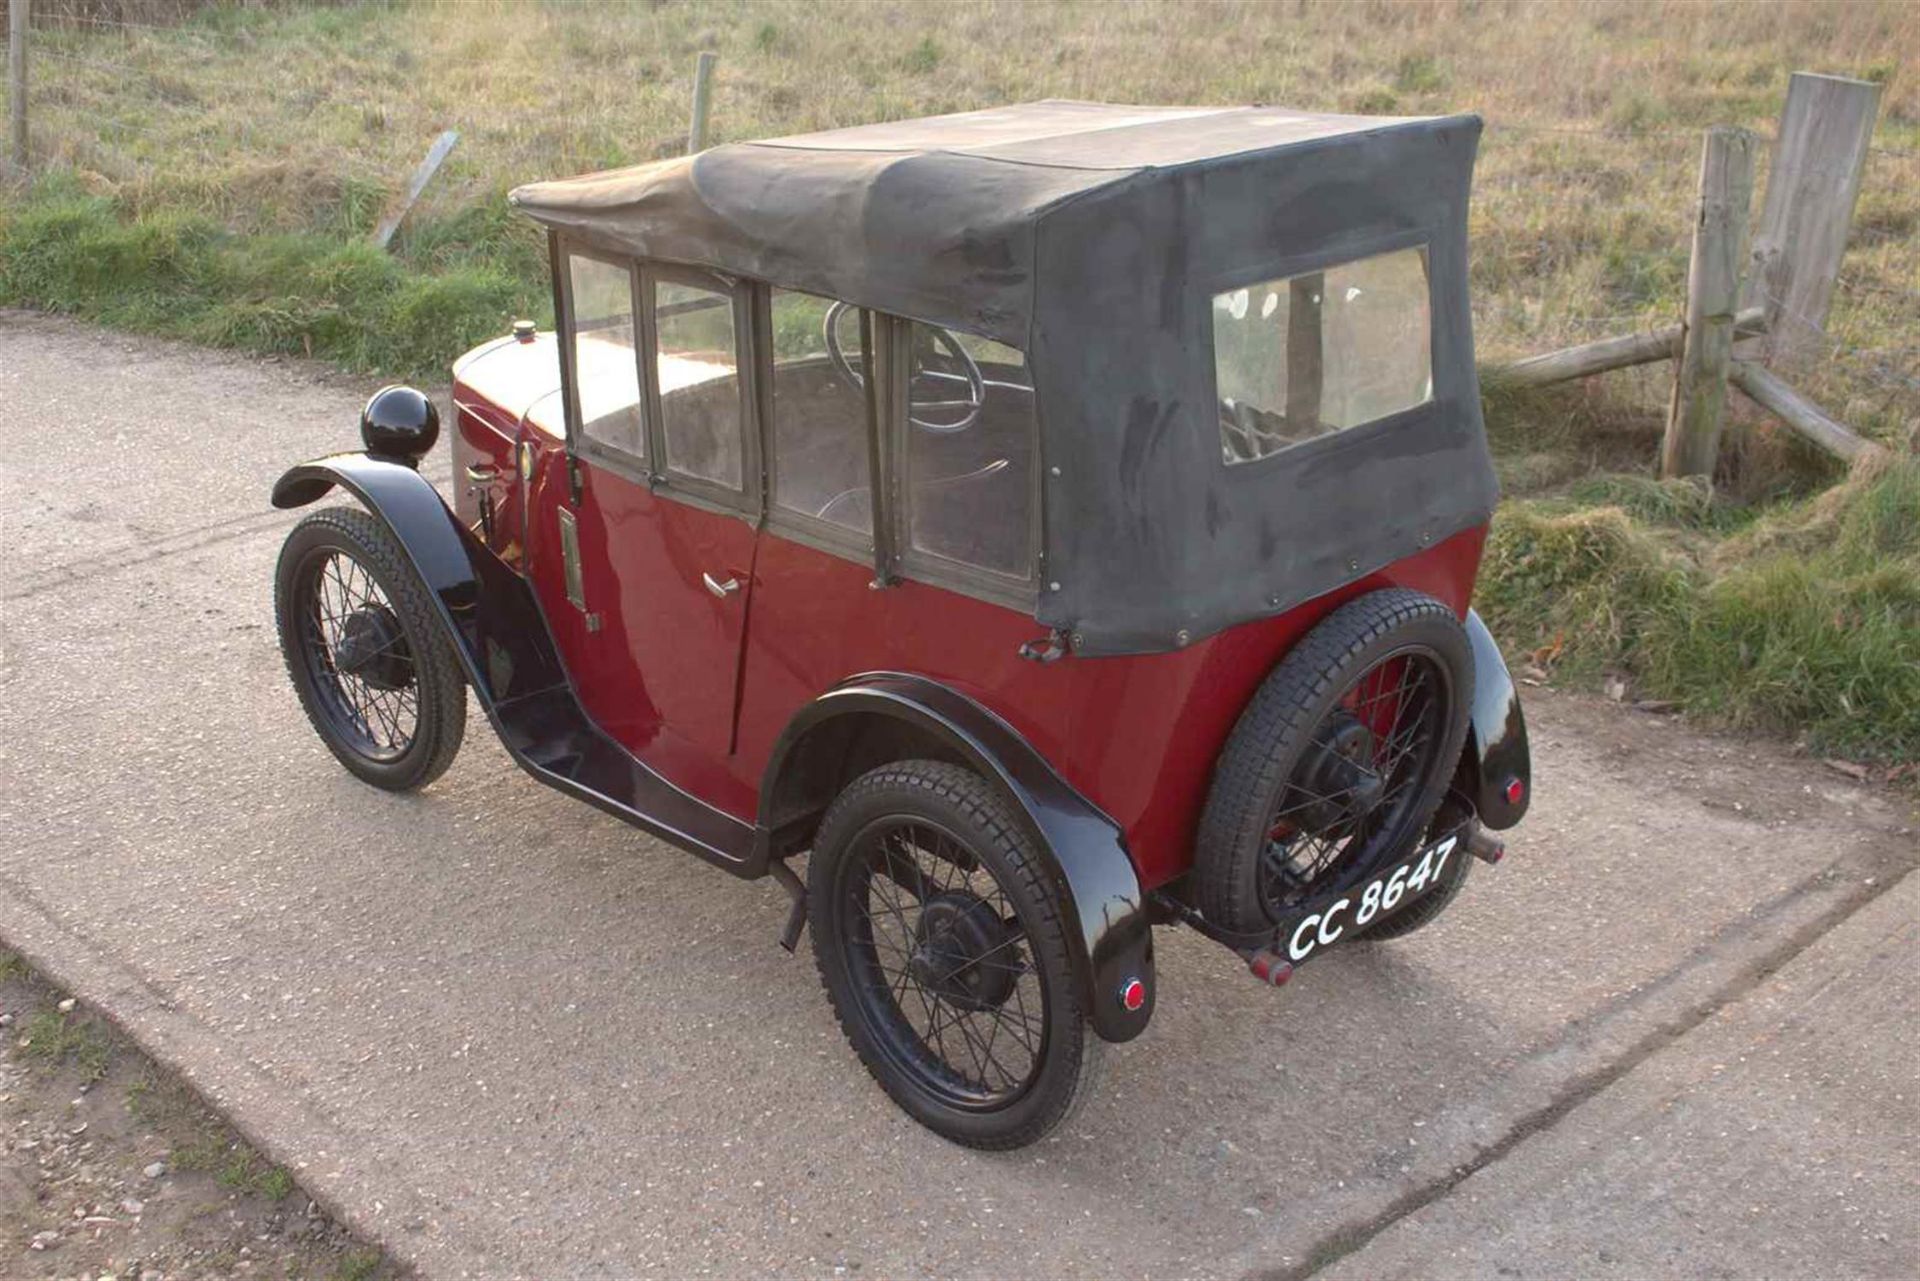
xmin=273 ymin=453 xmax=766 ymax=876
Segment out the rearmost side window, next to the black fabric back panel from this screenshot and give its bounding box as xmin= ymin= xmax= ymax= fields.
xmin=906 ymin=321 xmax=1037 ymax=580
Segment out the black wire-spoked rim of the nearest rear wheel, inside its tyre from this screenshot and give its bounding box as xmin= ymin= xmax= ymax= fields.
xmin=847 ymin=818 xmax=1046 ymax=1106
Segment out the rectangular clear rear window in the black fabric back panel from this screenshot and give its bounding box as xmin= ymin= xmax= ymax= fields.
xmin=1213 ymin=246 xmax=1434 ymax=465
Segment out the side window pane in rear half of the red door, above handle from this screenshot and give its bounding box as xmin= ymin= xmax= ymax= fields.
xmin=653 ymin=280 xmax=743 ymax=490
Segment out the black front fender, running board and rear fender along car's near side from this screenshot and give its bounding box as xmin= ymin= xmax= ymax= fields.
xmin=273 ymin=453 xmax=1156 ymax=1041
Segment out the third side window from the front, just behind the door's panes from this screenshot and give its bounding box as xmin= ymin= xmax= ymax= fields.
xmin=772 ymin=290 xmax=874 ymax=536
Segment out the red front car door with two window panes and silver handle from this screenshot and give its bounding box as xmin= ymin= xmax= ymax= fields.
xmin=555 ymin=250 xmax=758 ymax=820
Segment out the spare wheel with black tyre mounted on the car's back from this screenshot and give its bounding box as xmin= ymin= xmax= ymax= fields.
xmin=1194 ymin=588 xmax=1473 ymax=931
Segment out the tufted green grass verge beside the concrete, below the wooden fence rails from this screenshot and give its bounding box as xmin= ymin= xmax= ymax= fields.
xmin=1478 ymin=459 xmax=1920 ymax=762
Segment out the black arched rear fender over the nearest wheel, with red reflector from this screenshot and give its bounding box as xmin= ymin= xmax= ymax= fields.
xmin=760 ymin=672 xmax=1156 ymax=1041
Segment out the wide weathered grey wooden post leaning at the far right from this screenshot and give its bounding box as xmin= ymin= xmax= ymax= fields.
xmin=1740 ymin=71 xmax=1880 ymax=365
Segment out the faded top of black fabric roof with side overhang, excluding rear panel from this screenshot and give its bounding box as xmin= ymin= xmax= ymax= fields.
xmin=511 ymin=100 xmax=1430 ymax=348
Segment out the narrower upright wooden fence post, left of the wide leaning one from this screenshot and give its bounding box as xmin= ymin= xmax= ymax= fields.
xmin=1661 ymin=125 xmax=1753 ymax=476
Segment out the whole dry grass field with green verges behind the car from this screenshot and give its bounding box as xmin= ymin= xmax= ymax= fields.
xmin=11 ymin=0 xmax=1920 ymax=761
